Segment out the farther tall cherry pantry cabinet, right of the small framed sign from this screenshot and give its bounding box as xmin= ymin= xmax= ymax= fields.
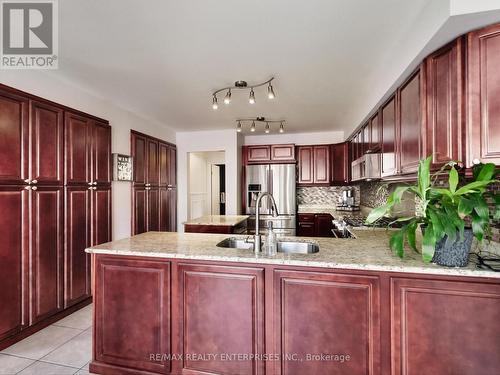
xmin=130 ymin=130 xmax=177 ymax=234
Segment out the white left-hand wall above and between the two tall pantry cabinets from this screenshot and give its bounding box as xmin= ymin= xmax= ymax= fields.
xmin=0 ymin=70 xmax=175 ymax=240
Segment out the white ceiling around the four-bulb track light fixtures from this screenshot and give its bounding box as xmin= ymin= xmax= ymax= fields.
xmin=48 ymin=0 xmax=496 ymax=132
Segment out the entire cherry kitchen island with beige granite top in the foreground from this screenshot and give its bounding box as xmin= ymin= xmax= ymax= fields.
xmin=87 ymin=230 xmax=500 ymax=375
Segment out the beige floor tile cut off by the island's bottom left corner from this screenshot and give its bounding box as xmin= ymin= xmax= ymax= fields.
xmin=41 ymin=331 xmax=92 ymax=368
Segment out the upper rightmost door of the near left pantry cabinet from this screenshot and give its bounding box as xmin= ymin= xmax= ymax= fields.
xmin=92 ymin=122 xmax=112 ymax=185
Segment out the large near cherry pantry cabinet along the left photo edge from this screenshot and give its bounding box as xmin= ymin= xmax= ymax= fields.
xmin=0 ymin=85 xmax=111 ymax=348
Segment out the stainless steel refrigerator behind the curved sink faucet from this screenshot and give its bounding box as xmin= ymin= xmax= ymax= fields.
xmin=245 ymin=164 xmax=297 ymax=236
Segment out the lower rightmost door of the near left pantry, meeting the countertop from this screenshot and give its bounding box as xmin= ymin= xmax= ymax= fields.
xmin=92 ymin=187 xmax=111 ymax=246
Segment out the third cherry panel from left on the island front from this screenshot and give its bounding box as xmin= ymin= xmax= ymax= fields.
xmin=274 ymin=271 xmax=380 ymax=375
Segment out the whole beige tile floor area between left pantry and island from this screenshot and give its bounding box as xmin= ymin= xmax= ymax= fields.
xmin=0 ymin=305 xmax=96 ymax=375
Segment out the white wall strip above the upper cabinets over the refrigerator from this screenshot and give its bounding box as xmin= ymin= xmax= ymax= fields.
xmin=243 ymin=131 xmax=344 ymax=145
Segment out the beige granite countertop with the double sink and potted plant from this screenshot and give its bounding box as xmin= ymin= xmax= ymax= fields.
xmin=86 ymin=230 xmax=500 ymax=278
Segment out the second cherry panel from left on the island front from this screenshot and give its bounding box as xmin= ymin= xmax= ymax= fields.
xmin=178 ymin=264 xmax=265 ymax=375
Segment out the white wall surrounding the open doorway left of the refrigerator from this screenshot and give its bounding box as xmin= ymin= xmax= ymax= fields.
xmin=175 ymin=129 xmax=241 ymax=232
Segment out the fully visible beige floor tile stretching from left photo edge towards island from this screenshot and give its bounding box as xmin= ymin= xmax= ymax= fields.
xmin=2 ymin=325 xmax=82 ymax=359
